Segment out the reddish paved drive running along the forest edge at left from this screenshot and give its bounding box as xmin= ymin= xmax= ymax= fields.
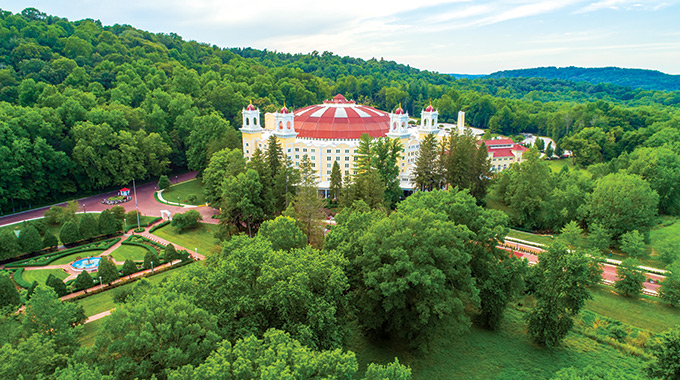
xmin=0 ymin=172 xmax=218 ymax=226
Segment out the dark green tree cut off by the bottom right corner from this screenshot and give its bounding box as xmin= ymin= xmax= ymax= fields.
xmin=646 ymin=327 xmax=680 ymax=379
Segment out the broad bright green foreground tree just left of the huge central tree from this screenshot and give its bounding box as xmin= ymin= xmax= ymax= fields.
xmin=169 ymin=235 xmax=349 ymax=349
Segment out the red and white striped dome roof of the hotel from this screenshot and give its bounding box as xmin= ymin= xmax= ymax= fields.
xmin=295 ymin=94 xmax=390 ymax=139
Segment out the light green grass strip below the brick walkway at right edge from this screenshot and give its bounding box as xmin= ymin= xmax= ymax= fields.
xmin=586 ymin=285 xmax=680 ymax=333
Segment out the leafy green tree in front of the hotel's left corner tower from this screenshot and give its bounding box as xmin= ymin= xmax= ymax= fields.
xmin=222 ymin=169 xmax=264 ymax=237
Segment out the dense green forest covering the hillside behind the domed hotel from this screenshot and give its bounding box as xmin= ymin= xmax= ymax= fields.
xmin=0 ymin=8 xmax=680 ymax=213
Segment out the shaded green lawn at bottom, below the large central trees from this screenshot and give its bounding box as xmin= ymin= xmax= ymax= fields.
xmin=348 ymin=309 xmax=643 ymax=380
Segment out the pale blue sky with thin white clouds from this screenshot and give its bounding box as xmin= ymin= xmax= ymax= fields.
xmin=0 ymin=0 xmax=680 ymax=74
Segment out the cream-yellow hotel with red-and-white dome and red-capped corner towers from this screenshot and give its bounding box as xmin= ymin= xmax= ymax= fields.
xmin=241 ymin=94 xmax=516 ymax=190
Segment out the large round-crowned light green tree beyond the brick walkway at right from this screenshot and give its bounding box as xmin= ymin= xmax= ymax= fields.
xmin=587 ymin=173 xmax=659 ymax=239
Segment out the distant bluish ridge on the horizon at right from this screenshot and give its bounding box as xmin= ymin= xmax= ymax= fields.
xmin=484 ymin=66 xmax=680 ymax=91
